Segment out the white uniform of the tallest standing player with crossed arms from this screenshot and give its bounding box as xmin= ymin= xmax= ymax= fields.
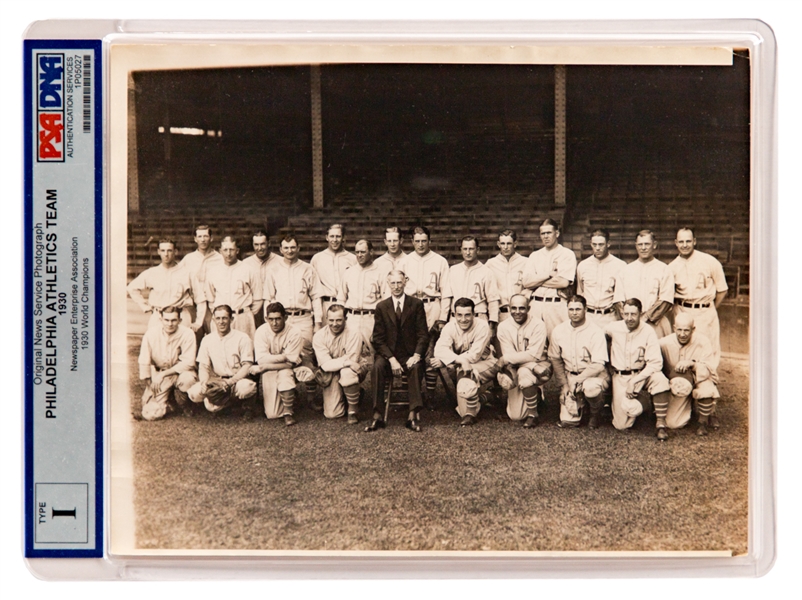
xmin=523 ymin=244 xmax=576 ymax=335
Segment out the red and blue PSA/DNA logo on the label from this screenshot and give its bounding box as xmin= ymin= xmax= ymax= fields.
xmin=36 ymin=54 xmax=64 ymax=162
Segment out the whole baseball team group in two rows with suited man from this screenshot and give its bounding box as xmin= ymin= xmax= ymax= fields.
xmin=128 ymin=219 xmax=727 ymax=441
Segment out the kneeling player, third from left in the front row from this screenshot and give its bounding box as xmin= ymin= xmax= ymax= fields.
xmin=249 ymin=302 xmax=312 ymax=427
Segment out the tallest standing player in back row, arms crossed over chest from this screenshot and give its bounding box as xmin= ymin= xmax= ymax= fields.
xmin=523 ymin=219 xmax=576 ymax=335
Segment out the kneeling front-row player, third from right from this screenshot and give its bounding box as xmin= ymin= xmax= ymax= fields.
xmin=549 ymin=295 xmax=610 ymax=429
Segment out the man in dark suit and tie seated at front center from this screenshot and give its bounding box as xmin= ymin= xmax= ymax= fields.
xmin=365 ymin=270 xmax=429 ymax=431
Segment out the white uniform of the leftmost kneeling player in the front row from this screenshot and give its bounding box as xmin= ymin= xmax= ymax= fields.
xmin=138 ymin=325 xmax=197 ymax=421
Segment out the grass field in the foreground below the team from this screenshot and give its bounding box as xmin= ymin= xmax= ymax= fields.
xmin=123 ymin=342 xmax=748 ymax=554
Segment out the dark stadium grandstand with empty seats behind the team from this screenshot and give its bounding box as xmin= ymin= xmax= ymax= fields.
xmin=129 ymin=55 xmax=750 ymax=302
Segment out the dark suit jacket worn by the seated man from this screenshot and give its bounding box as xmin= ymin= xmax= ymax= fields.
xmin=373 ymin=295 xmax=429 ymax=365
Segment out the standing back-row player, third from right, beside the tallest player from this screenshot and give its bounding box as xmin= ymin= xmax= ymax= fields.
xmin=576 ymin=229 xmax=626 ymax=330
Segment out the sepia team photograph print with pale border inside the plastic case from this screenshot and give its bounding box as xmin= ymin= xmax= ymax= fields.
xmin=109 ymin=45 xmax=752 ymax=556
